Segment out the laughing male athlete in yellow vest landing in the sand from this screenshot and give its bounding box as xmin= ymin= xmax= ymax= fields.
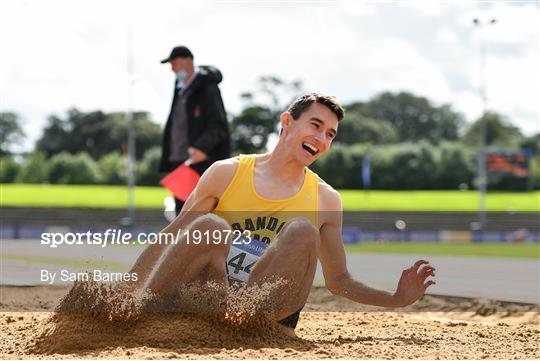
xmin=131 ymin=93 xmax=435 ymax=329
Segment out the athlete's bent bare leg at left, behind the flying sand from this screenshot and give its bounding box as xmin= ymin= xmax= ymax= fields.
xmin=134 ymin=214 xmax=230 ymax=295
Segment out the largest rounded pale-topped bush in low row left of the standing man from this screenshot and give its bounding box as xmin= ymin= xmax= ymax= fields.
xmin=49 ymin=152 xmax=101 ymax=184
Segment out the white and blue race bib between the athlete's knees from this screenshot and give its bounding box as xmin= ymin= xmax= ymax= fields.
xmin=227 ymin=237 xmax=268 ymax=282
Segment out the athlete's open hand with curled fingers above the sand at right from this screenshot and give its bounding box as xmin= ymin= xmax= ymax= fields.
xmin=394 ymin=260 xmax=435 ymax=307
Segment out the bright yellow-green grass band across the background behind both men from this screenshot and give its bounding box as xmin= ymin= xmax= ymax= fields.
xmin=0 ymin=184 xmax=540 ymax=212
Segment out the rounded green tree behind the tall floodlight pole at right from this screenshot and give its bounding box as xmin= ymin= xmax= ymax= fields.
xmin=463 ymin=112 xmax=523 ymax=149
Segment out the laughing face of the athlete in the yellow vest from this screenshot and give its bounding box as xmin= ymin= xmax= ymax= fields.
xmin=281 ymin=102 xmax=338 ymax=166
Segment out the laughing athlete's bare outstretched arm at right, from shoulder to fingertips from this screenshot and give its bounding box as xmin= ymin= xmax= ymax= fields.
xmin=319 ymin=186 xmax=434 ymax=307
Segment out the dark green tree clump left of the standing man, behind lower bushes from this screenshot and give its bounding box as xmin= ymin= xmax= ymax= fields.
xmin=36 ymin=109 xmax=161 ymax=159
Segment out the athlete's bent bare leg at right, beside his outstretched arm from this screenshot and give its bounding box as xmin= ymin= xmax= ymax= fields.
xmin=248 ymin=218 xmax=320 ymax=320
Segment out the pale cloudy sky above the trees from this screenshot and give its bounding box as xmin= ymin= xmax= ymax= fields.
xmin=0 ymin=0 xmax=540 ymax=151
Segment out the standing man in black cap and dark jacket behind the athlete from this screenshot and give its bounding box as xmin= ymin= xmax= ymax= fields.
xmin=159 ymin=46 xmax=231 ymax=214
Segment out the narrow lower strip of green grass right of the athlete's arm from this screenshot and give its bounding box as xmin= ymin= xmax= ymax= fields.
xmin=345 ymin=242 xmax=540 ymax=259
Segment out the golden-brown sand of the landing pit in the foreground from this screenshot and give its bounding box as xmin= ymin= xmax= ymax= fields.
xmin=0 ymin=287 xmax=540 ymax=359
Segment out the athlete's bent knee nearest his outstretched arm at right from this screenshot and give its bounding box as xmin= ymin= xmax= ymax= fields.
xmin=280 ymin=218 xmax=320 ymax=250
